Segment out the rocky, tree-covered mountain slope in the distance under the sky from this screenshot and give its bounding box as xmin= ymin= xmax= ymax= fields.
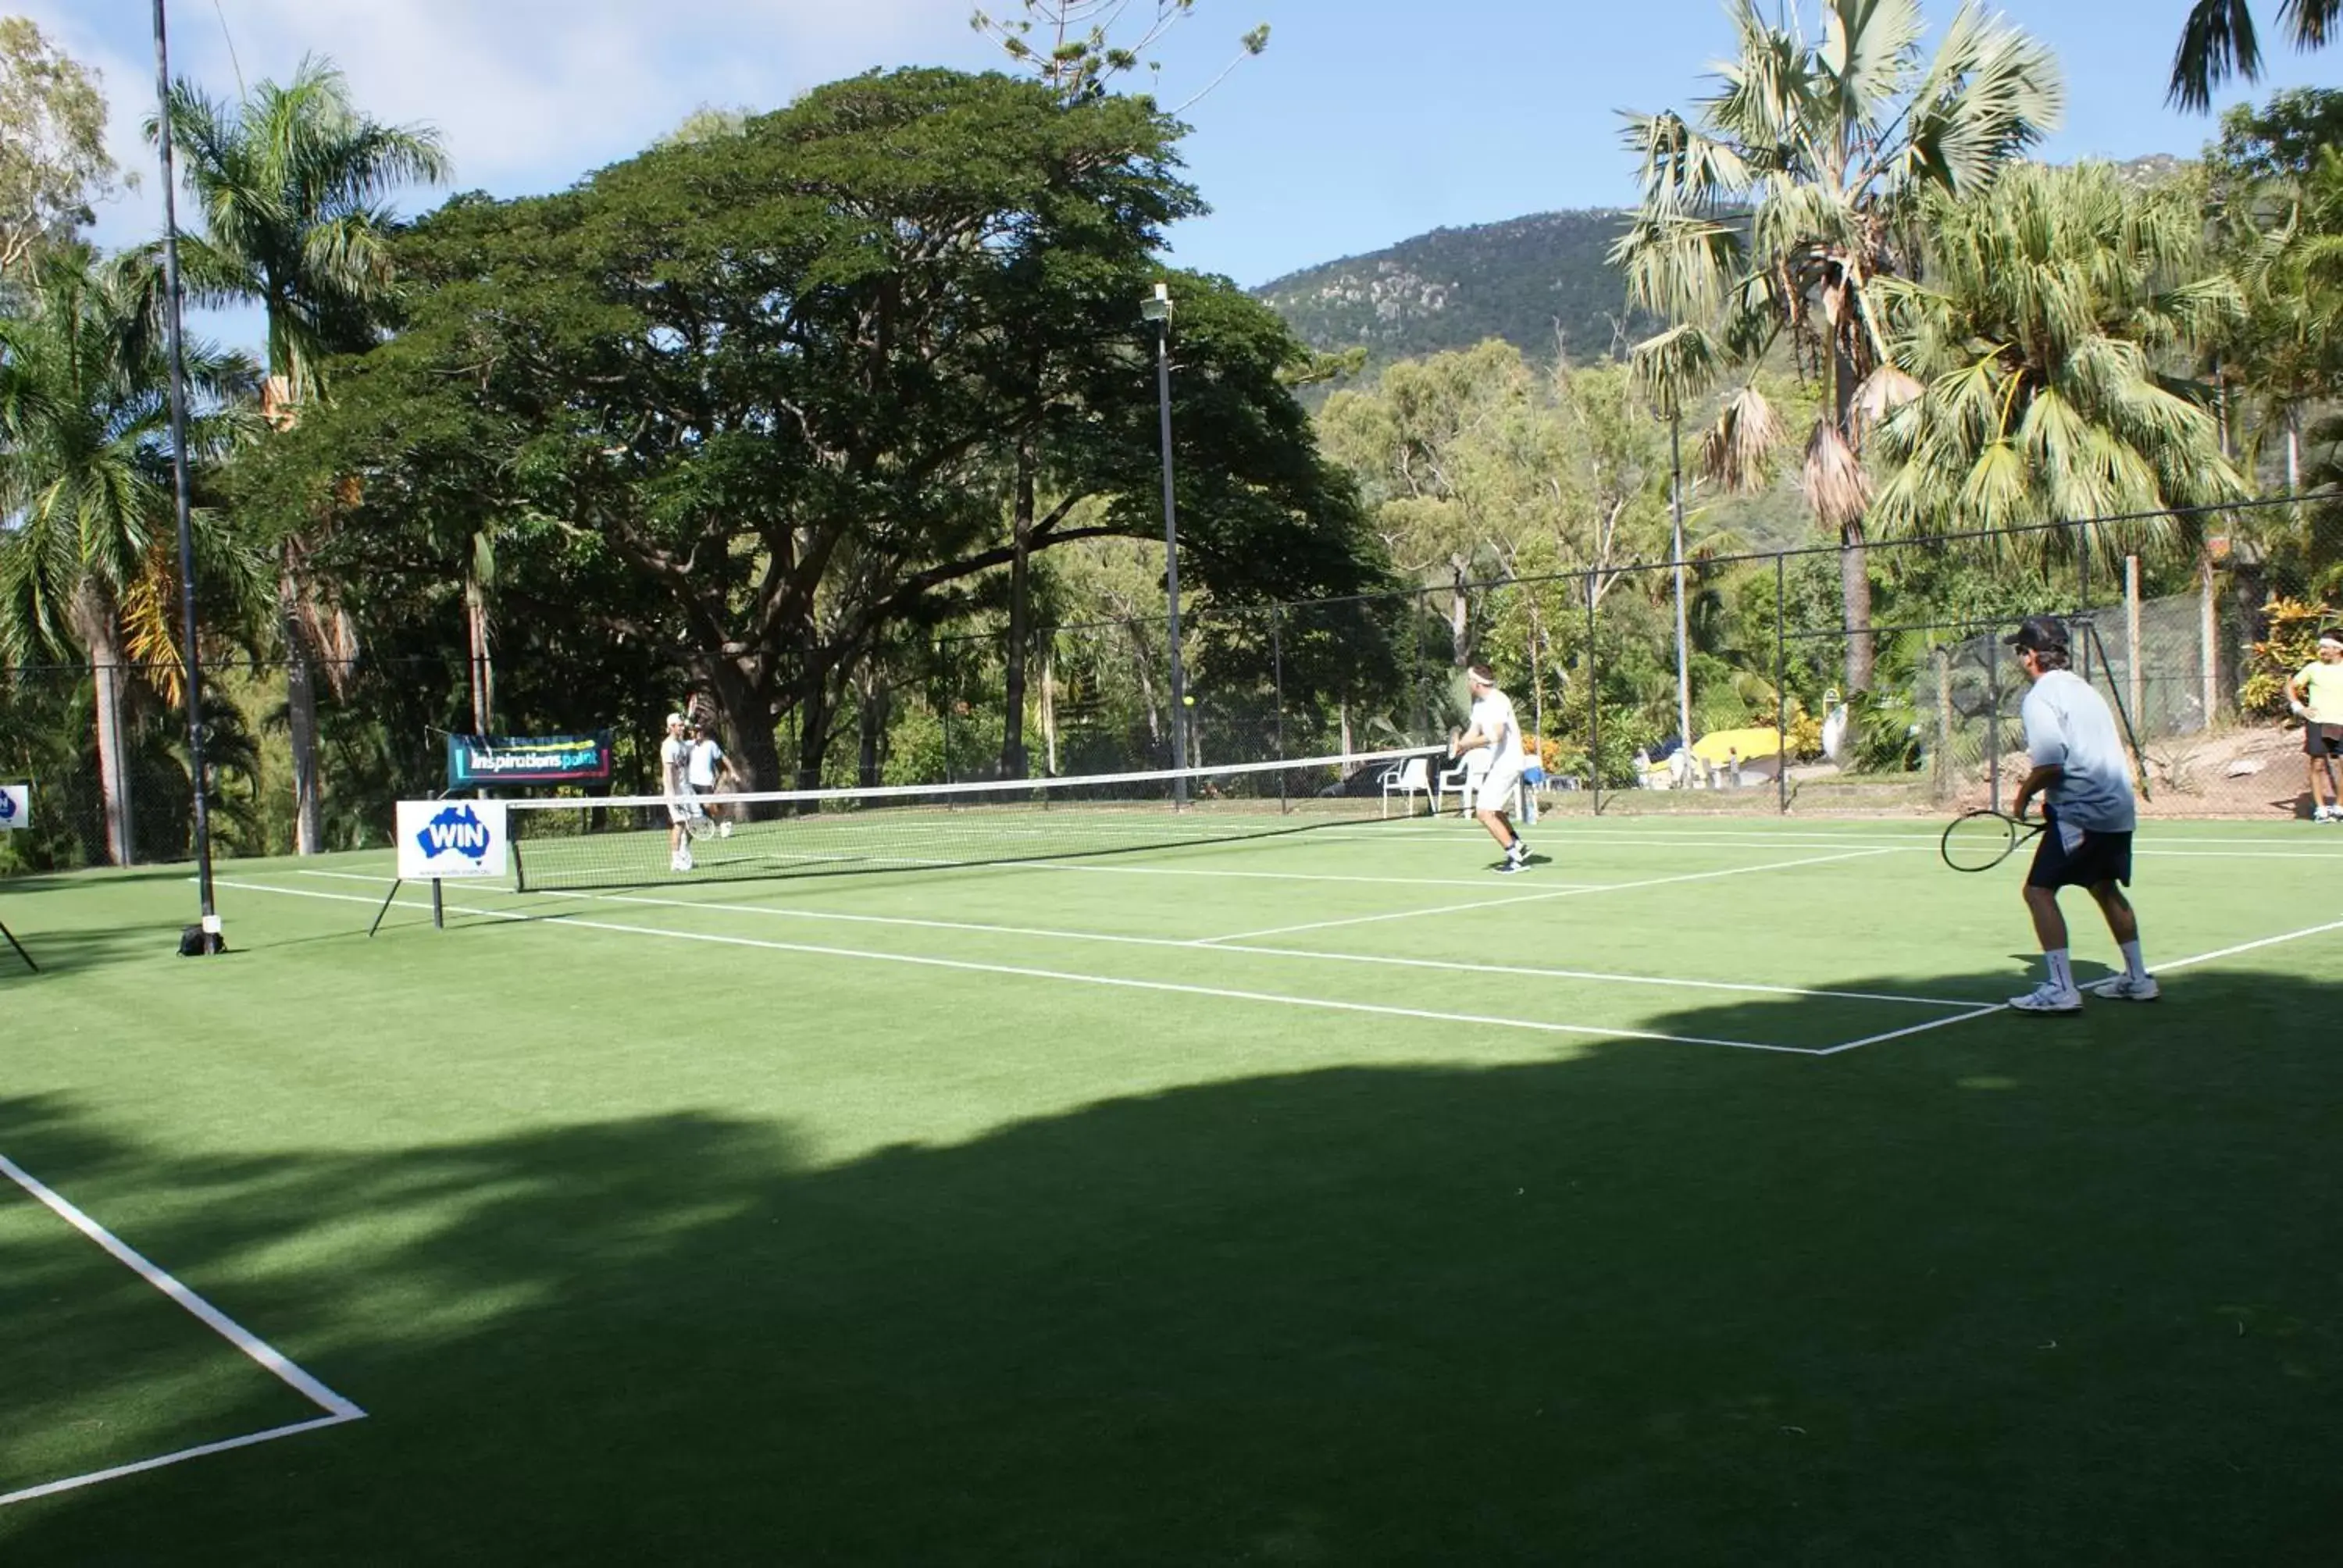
xmin=1254 ymin=211 xmax=1640 ymax=365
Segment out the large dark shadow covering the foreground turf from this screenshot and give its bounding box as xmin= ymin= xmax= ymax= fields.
xmin=0 ymin=968 xmax=2343 ymax=1568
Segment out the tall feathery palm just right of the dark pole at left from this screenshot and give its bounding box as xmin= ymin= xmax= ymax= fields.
xmin=150 ymin=56 xmax=450 ymax=856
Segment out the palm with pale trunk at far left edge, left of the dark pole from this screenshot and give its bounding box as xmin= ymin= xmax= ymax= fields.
xmin=0 ymin=246 xmax=260 ymax=865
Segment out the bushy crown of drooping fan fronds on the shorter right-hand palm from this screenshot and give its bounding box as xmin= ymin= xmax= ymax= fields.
xmin=1872 ymin=164 xmax=2247 ymax=551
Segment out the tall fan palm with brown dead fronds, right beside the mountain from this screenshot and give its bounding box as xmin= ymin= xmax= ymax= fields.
xmin=1612 ymin=0 xmax=2064 ymax=689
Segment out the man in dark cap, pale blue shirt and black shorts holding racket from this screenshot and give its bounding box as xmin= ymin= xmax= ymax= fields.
xmin=2010 ymin=614 xmax=2160 ymax=1013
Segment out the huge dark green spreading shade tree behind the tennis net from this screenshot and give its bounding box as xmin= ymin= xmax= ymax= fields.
xmin=247 ymin=70 xmax=1375 ymax=788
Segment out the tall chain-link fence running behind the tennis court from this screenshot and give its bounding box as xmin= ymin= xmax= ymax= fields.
xmin=0 ymin=497 xmax=2343 ymax=870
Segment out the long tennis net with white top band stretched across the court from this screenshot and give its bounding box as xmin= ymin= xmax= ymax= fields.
xmin=506 ymin=750 xmax=1441 ymax=893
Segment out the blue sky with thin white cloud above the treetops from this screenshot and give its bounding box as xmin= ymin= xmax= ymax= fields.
xmin=27 ymin=0 xmax=2343 ymax=337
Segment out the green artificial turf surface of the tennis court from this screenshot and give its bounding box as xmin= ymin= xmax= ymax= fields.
xmin=0 ymin=818 xmax=2343 ymax=1568
